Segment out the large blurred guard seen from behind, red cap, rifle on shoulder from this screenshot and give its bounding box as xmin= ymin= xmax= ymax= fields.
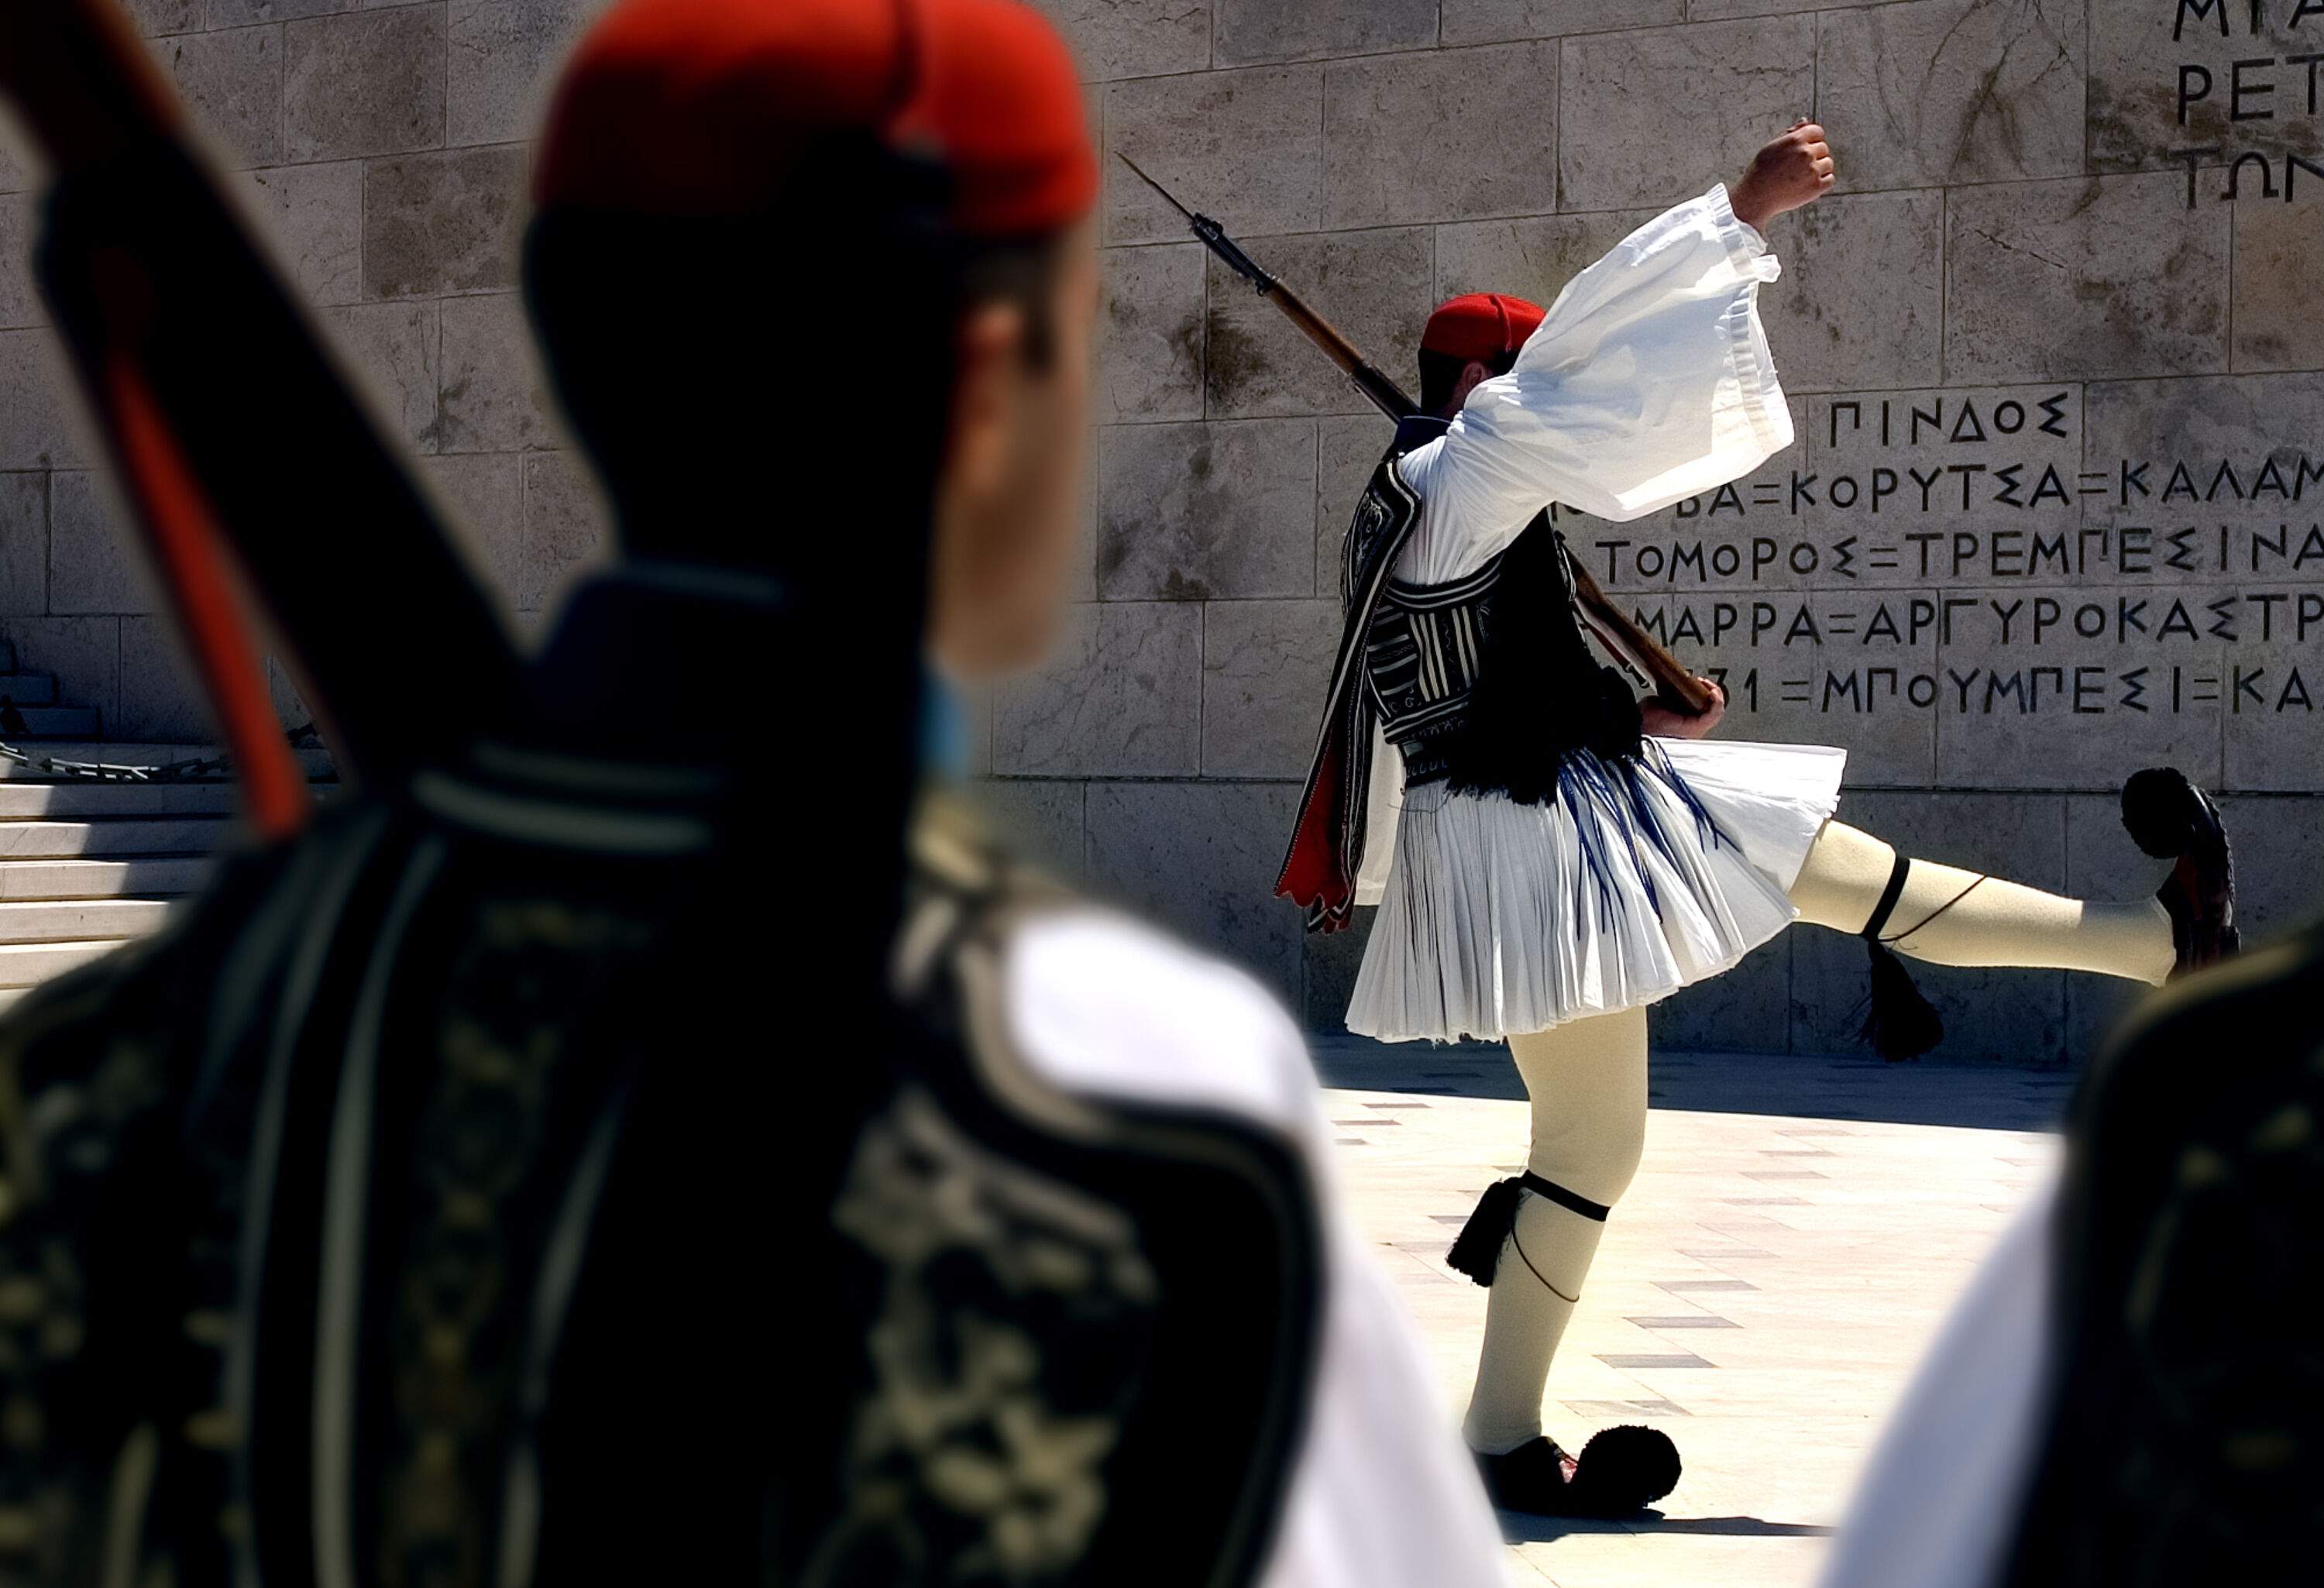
xmin=0 ymin=0 xmax=1499 ymax=1588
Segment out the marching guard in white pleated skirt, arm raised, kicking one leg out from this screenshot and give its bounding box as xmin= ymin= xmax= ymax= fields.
xmin=1278 ymin=121 xmax=2236 ymax=1514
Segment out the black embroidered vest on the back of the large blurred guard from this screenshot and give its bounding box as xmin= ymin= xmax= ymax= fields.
xmin=0 ymin=746 xmax=1322 ymax=1588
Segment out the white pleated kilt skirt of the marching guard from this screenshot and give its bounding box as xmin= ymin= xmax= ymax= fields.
xmin=1348 ymin=739 xmax=1848 ymax=1042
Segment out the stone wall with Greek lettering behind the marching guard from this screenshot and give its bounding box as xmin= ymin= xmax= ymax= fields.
xmin=990 ymin=0 xmax=2324 ymax=1065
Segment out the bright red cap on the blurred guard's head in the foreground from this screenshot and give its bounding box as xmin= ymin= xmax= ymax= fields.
xmin=535 ymin=0 xmax=1097 ymax=237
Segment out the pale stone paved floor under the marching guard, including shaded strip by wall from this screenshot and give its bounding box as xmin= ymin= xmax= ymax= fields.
xmin=1318 ymin=1040 xmax=2073 ymax=1588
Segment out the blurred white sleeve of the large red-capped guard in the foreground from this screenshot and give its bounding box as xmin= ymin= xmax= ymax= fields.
xmin=1006 ymin=909 xmax=1504 ymax=1588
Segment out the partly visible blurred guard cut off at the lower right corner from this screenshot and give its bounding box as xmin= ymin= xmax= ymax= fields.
xmin=1824 ymin=928 xmax=2324 ymax=1588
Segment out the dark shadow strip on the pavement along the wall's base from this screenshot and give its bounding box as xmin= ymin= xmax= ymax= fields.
xmin=1311 ymin=1035 xmax=2078 ymax=1130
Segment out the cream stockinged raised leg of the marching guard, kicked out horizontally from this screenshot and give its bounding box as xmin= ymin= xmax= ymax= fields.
xmin=1792 ymin=821 xmax=2178 ymax=986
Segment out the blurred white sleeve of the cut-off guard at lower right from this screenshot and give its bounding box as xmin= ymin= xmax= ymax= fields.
xmin=1822 ymin=1188 xmax=2057 ymax=1588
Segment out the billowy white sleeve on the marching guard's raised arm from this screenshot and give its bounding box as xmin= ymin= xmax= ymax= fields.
xmin=1401 ymin=186 xmax=1792 ymax=581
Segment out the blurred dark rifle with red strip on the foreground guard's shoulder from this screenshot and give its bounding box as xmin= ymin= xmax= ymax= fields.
xmin=15 ymin=0 xmax=516 ymax=799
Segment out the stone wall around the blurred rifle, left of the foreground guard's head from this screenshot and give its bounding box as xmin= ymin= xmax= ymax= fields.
xmin=0 ymin=0 xmax=604 ymax=741
